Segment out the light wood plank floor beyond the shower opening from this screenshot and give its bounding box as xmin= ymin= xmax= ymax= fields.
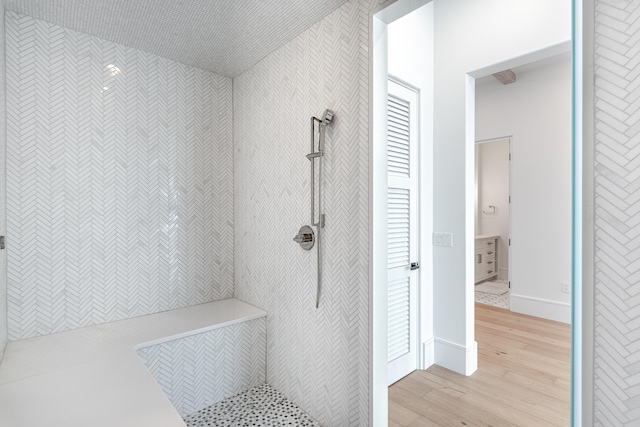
xmin=389 ymin=304 xmax=571 ymax=427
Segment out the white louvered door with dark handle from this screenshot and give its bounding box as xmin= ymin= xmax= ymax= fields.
xmin=387 ymin=79 xmax=419 ymax=385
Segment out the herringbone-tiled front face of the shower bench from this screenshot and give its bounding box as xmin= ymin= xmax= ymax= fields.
xmin=138 ymin=317 xmax=267 ymax=417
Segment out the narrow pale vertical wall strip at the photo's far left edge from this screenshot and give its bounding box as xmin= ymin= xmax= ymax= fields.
xmin=0 ymin=0 xmax=8 ymax=361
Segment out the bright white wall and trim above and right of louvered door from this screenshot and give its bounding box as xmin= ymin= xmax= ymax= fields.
xmin=387 ymin=3 xmax=433 ymax=368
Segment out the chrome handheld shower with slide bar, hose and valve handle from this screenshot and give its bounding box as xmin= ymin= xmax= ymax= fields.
xmin=293 ymin=109 xmax=333 ymax=308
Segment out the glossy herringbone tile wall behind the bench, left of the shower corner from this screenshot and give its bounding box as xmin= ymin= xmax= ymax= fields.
xmin=6 ymin=12 xmax=233 ymax=340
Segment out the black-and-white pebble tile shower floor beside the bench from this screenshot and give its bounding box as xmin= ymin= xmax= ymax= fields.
xmin=184 ymin=384 xmax=320 ymax=427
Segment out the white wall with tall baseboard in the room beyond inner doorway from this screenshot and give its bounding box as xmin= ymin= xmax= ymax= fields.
xmin=476 ymin=53 xmax=571 ymax=323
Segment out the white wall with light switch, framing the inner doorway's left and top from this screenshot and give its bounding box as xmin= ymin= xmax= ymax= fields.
xmin=433 ymin=0 xmax=571 ymax=372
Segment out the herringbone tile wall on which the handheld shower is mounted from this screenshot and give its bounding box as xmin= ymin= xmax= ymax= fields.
xmin=234 ymin=0 xmax=378 ymax=427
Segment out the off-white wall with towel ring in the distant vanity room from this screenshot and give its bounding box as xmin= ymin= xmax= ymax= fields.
xmin=476 ymin=139 xmax=509 ymax=280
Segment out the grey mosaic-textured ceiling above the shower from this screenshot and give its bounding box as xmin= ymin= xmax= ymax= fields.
xmin=4 ymin=0 xmax=346 ymax=77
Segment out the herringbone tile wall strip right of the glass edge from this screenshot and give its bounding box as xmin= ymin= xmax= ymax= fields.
xmin=594 ymin=0 xmax=640 ymax=426
